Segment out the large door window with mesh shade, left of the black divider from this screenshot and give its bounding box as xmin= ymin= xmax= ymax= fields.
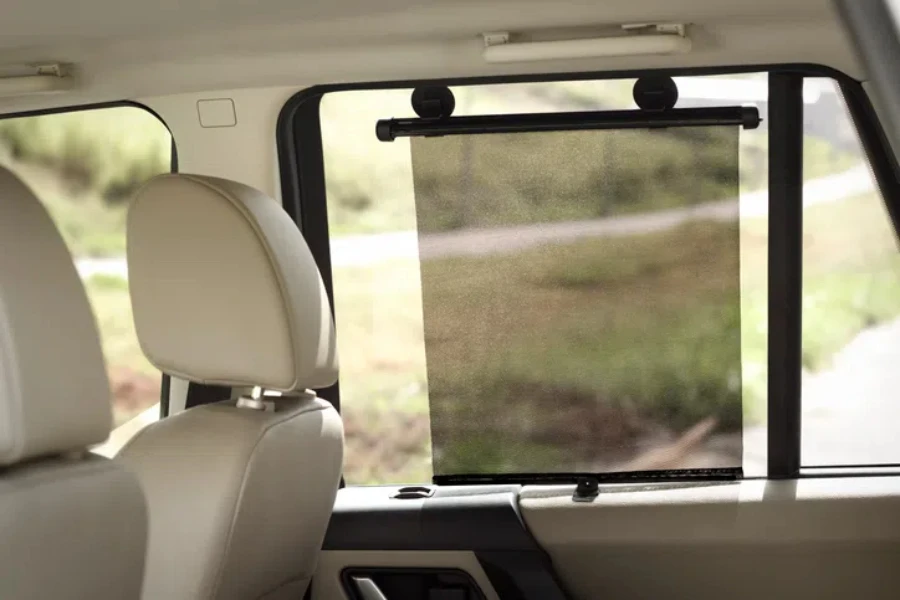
xmin=321 ymin=74 xmax=788 ymax=484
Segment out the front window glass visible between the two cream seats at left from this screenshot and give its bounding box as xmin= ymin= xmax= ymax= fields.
xmin=0 ymin=107 xmax=172 ymax=426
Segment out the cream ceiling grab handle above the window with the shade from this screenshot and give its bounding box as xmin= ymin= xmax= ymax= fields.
xmin=483 ymin=23 xmax=691 ymax=63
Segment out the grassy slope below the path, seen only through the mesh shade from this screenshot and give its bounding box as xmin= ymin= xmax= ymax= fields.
xmin=422 ymin=222 xmax=742 ymax=472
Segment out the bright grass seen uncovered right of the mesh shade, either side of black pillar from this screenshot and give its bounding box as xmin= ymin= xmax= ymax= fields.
xmin=741 ymin=192 xmax=900 ymax=424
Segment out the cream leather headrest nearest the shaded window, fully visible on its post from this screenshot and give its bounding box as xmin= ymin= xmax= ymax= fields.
xmin=127 ymin=175 xmax=337 ymax=392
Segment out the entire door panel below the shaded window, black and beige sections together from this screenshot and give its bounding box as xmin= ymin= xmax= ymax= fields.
xmin=313 ymin=476 xmax=900 ymax=600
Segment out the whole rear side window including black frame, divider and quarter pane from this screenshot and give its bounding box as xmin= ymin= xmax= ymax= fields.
xmin=298 ymin=68 xmax=900 ymax=484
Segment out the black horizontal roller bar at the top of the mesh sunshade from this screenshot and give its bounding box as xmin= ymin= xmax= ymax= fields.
xmin=375 ymin=106 xmax=761 ymax=142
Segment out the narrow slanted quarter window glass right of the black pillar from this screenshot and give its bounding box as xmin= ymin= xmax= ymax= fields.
xmin=801 ymin=79 xmax=900 ymax=466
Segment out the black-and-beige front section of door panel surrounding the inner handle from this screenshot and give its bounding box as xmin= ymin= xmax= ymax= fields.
xmin=314 ymin=485 xmax=567 ymax=600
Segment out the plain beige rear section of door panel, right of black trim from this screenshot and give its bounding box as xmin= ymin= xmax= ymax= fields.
xmin=520 ymin=477 xmax=900 ymax=600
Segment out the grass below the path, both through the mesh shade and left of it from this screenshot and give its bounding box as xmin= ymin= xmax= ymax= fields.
xmin=335 ymin=224 xmax=741 ymax=483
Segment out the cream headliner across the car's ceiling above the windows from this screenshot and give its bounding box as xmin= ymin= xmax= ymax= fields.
xmin=0 ymin=0 xmax=863 ymax=112
